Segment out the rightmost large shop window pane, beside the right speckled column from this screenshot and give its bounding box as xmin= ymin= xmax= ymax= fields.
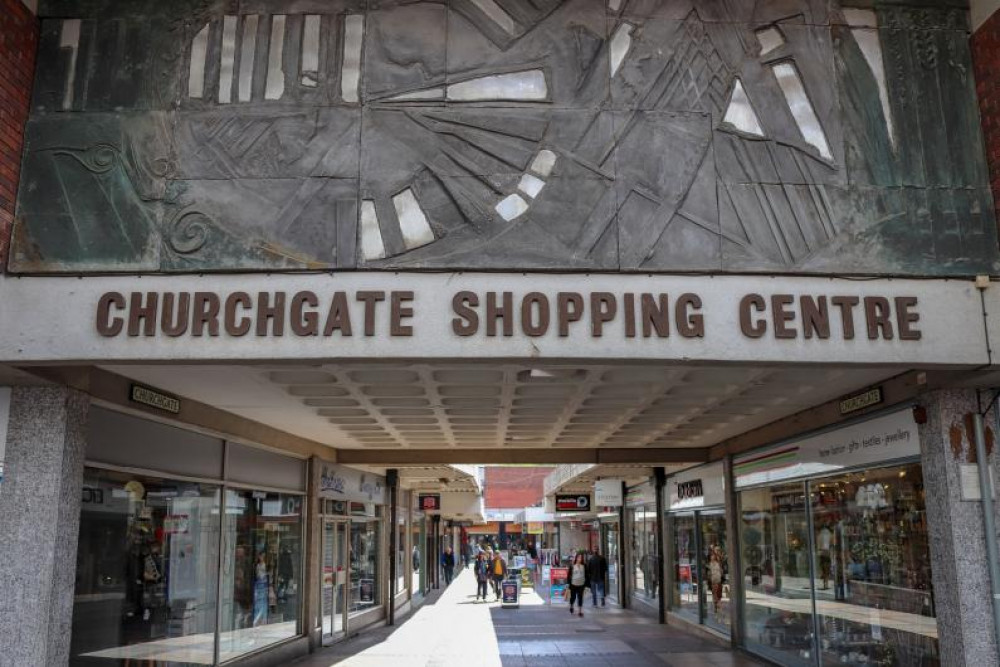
xmin=809 ymin=465 xmax=938 ymax=665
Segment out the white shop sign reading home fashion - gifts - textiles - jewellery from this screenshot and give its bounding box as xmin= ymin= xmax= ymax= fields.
xmin=733 ymin=409 xmax=920 ymax=487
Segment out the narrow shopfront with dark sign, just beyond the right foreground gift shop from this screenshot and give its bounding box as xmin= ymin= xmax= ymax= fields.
xmin=667 ymin=463 xmax=732 ymax=634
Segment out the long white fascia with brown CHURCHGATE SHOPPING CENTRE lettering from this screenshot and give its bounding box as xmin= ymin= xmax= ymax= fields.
xmin=0 ymin=273 xmax=987 ymax=365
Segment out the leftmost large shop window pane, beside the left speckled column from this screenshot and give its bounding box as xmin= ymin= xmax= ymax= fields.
xmin=70 ymin=469 xmax=219 ymax=665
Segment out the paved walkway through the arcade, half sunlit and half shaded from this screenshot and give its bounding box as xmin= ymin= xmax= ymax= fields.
xmin=295 ymin=570 xmax=762 ymax=667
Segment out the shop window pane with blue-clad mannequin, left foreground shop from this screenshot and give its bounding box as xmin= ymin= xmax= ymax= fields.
xmin=219 ymin=489 xmax=303 ymax=661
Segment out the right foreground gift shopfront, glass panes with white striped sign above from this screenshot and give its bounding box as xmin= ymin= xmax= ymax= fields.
xmin=734 ymin=411 xmax=940 ymax=667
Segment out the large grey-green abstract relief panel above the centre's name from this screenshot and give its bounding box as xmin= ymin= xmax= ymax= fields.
xmin=10 ymin=0 xmax=997 ymax=275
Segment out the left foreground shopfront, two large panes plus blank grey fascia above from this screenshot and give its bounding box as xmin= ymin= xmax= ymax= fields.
xmin=69 ymin=408 xmax=305 ymax=666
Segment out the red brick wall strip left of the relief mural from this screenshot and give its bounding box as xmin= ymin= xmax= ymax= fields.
xmin=0 ymin=0 xmax=38 ymax=269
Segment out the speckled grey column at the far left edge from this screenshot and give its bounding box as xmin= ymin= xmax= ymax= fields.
xmin=0 ymin=387 xmax=90 ymax=667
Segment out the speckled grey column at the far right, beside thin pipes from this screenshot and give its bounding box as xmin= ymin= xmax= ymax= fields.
xmin=919 ymin=390 xmax=1000 ymax=667
